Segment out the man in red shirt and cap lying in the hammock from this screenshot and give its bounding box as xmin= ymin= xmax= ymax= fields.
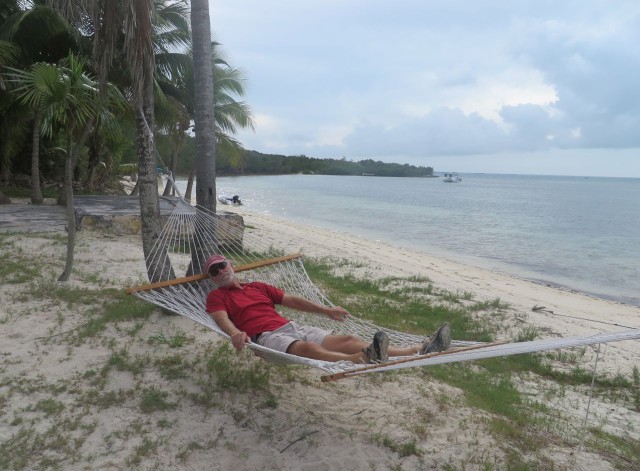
xmin=205 ymin=255 xmax=451 ymax=363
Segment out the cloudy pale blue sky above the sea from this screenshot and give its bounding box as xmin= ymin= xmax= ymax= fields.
xmin=210 ymin=0 xmax=640 ymax=177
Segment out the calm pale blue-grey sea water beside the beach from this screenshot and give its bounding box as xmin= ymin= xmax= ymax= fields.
xmin=177 ymin=174 xmax=640 ymax=306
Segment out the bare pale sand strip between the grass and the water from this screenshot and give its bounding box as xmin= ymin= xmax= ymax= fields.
xmin=230 ymin=207 xmax=640 ymax=373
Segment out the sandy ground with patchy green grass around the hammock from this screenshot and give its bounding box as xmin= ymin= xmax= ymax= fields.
xmin=0 ymin=234 xmax=640 ymax=470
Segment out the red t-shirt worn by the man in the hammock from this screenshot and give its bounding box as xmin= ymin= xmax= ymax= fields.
xmin=206 ymin=281 xmax=289 ymax=337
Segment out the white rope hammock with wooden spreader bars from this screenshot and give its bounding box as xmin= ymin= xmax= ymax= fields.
xmin=126 ymin=196 xmax=640 ymax=381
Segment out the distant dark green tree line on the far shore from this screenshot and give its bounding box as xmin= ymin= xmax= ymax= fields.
xmin=158 ymin=138 xmax=433 ymax=177
